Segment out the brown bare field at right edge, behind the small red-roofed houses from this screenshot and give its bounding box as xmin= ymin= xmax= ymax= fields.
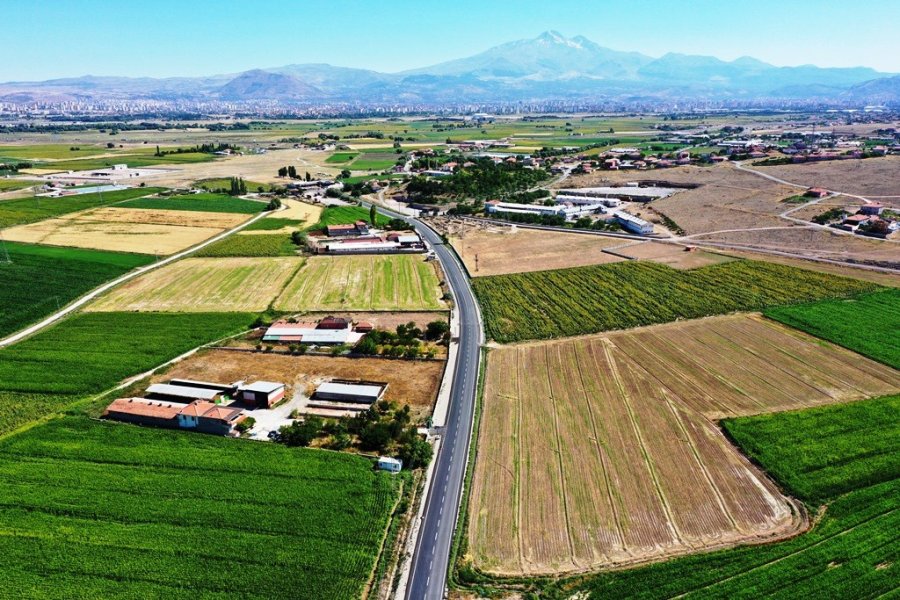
xmin=753 ymin=156 xmax=900 ymax=199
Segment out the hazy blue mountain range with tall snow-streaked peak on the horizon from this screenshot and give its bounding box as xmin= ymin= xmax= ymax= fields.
xmin=0 ymin=31 xmax=900 ymax=105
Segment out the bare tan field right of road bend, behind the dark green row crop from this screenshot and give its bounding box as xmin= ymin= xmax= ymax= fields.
xmin=450 ymin=226 xmax=624 ymax=277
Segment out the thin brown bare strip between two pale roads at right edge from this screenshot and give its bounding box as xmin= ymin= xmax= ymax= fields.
xmin=693 ymin=227 xmax=900 ymax=267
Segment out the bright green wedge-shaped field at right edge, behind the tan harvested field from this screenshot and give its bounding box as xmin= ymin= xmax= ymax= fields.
xmin=765 ymin=288 xmax=900 ymax=369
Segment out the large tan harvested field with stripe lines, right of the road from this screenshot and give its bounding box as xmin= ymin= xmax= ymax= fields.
xmin=468 ymin=316 xmax=900 ymax=575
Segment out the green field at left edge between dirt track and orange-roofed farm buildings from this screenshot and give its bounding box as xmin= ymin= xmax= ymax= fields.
xmin=0 ymin=313 xmax=254 ymax=433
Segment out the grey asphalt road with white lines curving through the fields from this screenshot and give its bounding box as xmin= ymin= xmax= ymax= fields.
xmin=368 ymin=208 xmax=482 ymax=600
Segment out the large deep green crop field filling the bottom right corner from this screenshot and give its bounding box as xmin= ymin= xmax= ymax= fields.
xmin=541 ymin=396 xmax=900 ymax=600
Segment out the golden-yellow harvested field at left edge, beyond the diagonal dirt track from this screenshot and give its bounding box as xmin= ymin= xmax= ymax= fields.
xmin=3 ymin=207 xmax=249 ymax=255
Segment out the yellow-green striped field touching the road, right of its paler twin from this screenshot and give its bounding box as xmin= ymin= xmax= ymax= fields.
xmin=273 ymin=254 xmax=446 ymax=311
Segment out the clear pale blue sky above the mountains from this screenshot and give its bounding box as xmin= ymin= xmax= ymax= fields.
xmin=7 ymin=0 xmax=900 ymax=81
